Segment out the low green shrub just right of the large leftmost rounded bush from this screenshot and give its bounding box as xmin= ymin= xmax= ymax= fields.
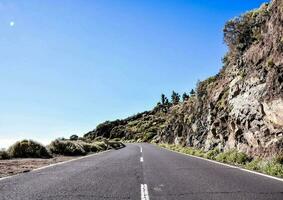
xmin=48 ymin=140 xmax=87 ymax=156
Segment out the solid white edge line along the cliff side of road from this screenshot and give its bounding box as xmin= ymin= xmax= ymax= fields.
xmin=161 ymin=147 xmax=283 ymax=182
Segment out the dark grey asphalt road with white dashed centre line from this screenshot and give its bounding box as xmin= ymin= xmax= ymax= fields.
xmin=0 ymin=144 xmax=283 ymax=200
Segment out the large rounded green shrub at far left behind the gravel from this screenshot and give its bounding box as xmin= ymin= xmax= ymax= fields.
xmin=7 ymin=140 xmax=51 ymax=158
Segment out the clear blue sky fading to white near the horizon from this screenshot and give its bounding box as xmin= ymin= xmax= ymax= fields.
xmin=0 ymin=0 xmax=265 ymax=147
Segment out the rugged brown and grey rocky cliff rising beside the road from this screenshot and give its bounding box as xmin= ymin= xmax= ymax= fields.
xmin=85 ymin=0 xmax=283 ymax=157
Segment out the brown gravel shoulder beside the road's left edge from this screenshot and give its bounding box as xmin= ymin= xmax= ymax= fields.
xmin=0 ymin=156 xmax=78 ymax=178
